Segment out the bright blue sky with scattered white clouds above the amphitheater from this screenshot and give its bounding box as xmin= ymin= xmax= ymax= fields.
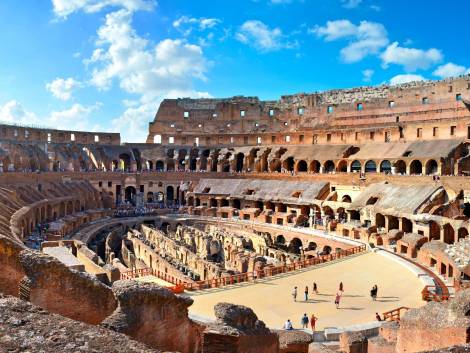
xmin=0 ymin=0 xmax=470 ymax=142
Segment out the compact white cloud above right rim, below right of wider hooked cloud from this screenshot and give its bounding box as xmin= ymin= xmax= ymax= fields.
xmin=381 ymin=42 xmax=443 ymax=72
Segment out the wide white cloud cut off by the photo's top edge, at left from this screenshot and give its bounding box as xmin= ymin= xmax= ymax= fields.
xmin=52 ymin=0 xmax=157 ymax=18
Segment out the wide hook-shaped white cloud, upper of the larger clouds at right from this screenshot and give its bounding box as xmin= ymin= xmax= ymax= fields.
xmin=309 ymin=20 xmax=389 ymax=63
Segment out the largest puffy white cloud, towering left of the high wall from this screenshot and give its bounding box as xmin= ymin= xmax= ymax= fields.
xmin=87 ymin=10 xmax=208 ymax=100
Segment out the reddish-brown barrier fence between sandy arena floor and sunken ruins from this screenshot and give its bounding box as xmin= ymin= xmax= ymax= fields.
xmin=121 ymin=245 xmax=367 ymax=293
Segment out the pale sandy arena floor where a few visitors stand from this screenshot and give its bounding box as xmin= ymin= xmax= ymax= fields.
xmin=188 ymin=253 xmax=425 ymax=330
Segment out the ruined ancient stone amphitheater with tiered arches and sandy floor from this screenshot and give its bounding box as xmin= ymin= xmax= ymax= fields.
xmin=0 ymin=76 xmax=470 ymax=353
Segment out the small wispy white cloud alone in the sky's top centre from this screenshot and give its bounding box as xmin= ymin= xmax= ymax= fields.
xmin=235 ymin=20 xmax=297 ymax=52
